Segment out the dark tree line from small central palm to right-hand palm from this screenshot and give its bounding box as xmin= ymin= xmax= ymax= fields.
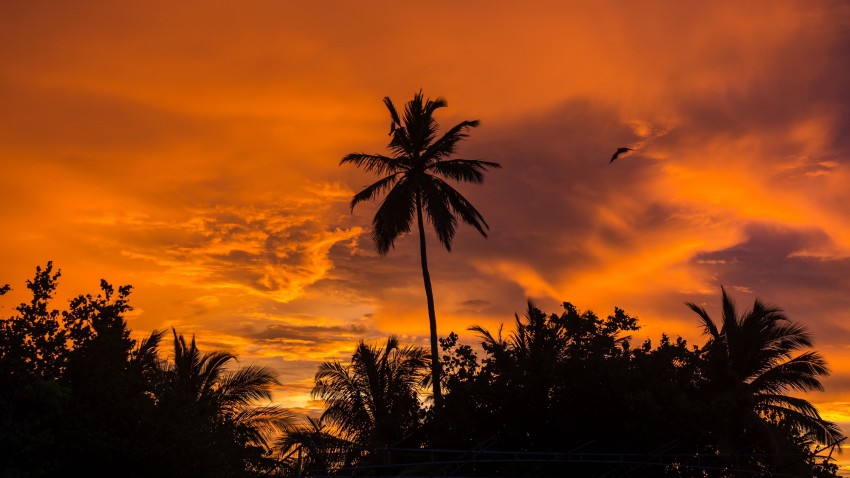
xmin=290 ymin=298 xmax=844 ymax=476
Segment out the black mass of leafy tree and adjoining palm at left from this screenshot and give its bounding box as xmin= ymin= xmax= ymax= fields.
xmin=0 ymin=262 xmax=285 ymax=477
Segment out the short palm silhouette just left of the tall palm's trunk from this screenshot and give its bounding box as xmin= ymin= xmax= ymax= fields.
xmin=313 ymin=337 xmax=428 ymax=446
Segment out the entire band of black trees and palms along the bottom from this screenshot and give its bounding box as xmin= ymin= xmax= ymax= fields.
xmin=0 ymin=263 xmax=844 ymax=477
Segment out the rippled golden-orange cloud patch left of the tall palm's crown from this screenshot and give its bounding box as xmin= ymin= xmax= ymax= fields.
xmin=76 ymin=197 xmax=361 ymax=302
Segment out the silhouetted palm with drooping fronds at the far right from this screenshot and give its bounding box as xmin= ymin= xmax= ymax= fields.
xmin=687 ymin=288 xmax=843 ymax=460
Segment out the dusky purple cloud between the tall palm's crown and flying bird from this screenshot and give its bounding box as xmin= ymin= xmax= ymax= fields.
xmin=458 ymin=100 xmax=644 ymax=271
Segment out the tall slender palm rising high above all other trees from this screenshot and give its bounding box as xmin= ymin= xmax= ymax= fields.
xmin=340 ymin=90 xmax=501 ymax=405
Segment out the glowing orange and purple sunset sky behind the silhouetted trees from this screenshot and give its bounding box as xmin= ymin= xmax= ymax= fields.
xmin=0 ymin=0 xmax=850 ymax=460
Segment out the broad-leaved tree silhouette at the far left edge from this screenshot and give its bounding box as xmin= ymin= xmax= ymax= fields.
xmin=0 ymin=262 xmax=166 ymax=476
